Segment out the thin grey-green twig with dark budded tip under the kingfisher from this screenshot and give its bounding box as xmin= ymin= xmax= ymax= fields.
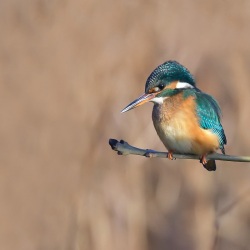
xmin=109 ymin=139 xmax=250 ymax=162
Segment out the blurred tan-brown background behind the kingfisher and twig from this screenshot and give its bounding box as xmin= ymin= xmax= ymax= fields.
xmin=0 ymin=0 xmax=250 ymax=250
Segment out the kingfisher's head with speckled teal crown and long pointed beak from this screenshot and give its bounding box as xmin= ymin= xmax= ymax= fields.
xmin=121 ymin=61 xmax=195 ymax=113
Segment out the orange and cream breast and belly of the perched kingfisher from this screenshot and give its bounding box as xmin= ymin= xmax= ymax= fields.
xmin=152 ymin=94 xmax=219 ymax=155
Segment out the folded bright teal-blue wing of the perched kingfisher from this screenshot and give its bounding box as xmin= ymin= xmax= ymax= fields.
xmin=195 ymin=91 xmax=227 ymax=153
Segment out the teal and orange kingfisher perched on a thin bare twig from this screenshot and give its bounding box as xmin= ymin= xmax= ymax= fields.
xmin=121 ymin=61 xmax=227 ymax=171
